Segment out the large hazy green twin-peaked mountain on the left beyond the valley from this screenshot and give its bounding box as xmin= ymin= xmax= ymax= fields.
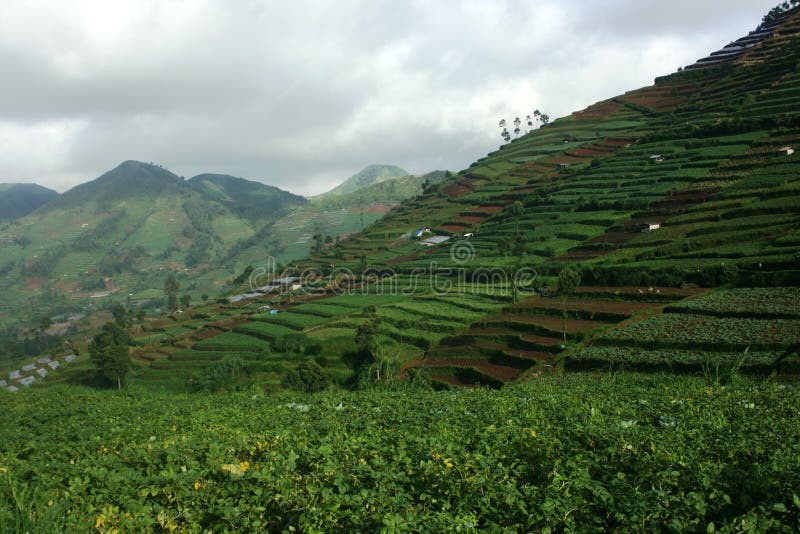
xmin=0 ymin=161 xmax=306 ymax=326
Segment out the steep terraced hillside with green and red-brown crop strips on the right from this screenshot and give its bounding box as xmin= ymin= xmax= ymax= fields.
xmin=114 ymin=3 xmax=800 ymax=394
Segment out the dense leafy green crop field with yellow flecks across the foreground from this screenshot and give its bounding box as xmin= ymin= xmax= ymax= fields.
xmin=0 ymin=374 xmax=800 ymax=532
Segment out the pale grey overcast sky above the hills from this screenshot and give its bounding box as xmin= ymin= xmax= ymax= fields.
xmin=0 ymin=0 xmax=778 ymax=194
